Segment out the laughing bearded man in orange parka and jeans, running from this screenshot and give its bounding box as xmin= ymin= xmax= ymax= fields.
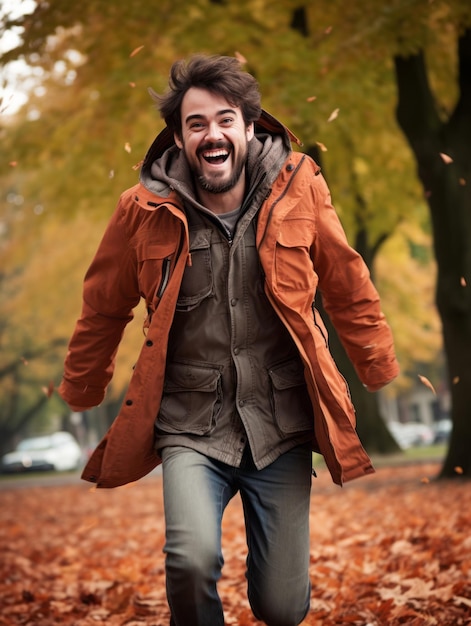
xmin=60 ymin=56 xmax=398 ymax=626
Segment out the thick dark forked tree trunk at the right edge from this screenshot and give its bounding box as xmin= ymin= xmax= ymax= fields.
xmin=394 ymin=30 xmax=471 ymax=478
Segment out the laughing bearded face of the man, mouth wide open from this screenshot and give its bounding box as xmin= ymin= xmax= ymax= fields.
xmin=175 ymin=87 xmax=254 ymax=194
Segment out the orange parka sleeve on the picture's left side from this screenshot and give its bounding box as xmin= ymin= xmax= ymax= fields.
xmin=58 ymin=197 xmax=140 ymax=410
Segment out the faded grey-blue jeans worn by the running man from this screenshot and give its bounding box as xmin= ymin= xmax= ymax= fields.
xmin=162 ymin=445 xmax=312 ymax=626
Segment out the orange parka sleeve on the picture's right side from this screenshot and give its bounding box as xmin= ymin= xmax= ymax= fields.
xmin=312 ymin=175 xmax=399 ymax=391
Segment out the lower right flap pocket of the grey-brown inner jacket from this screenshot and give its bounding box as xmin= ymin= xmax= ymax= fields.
xmin=268 ymin=360 xmax=314 ymax=434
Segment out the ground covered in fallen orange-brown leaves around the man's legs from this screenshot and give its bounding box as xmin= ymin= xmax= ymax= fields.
xmin=0 ymin=464 xmax=471 ymax=626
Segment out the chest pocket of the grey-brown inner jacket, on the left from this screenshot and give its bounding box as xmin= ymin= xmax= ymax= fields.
xmin=177 ymin=228 xmax=213 ymax=311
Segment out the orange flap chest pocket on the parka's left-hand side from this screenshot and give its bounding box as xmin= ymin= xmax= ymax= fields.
xmin=136 ymin=243 xmax=175 ymax=303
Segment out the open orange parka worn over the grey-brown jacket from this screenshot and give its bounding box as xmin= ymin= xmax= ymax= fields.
xmin=59 ymin=113 xmax=398 ymax=487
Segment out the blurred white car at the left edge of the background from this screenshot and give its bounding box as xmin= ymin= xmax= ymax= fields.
xmin=2 ymin=431 xmax=83 ymax=473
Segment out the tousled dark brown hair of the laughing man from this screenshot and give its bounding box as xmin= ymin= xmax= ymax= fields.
xmin=149 ymin=55 xmax=261 ymax=136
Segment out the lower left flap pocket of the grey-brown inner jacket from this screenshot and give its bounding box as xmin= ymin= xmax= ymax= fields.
xmin=156 ymin=363 xmax=222 ymax=435
